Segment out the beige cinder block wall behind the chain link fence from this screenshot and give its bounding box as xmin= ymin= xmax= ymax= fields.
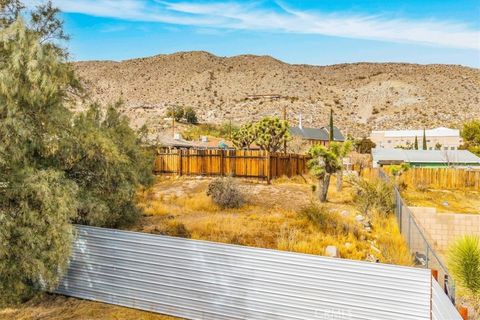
xmin=409 ymin=207 xmax=480 ymax=253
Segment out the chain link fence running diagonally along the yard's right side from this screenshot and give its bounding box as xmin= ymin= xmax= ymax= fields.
xmin=379 ymin=169 xmax=455 ymax=304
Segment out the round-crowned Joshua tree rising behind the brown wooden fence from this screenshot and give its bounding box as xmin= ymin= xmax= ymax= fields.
xmin=254 ymin=117 xmax=290 ymax=152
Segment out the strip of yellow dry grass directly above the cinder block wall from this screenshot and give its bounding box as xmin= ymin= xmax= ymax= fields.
xmin=402 ymin=187 xmax=480 ymax=214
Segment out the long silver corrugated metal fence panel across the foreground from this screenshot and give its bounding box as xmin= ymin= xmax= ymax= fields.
xmin=57 ymin=226 xmax=431 ymax=320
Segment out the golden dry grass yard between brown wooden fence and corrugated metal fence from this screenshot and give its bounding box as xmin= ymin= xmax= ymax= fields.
xmin=134 ymin=177 xmax=411 ymax=265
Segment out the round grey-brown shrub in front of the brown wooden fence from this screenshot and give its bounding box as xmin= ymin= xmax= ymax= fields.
xmin=207 ymin=177 xmax=245 ymax=209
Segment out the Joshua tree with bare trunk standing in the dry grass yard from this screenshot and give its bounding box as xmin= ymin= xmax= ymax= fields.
xmin=307 ymin=143 xmax=342 ymax=202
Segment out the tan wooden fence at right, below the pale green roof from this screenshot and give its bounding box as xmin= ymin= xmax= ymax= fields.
xmin=385 ymin=167 xmax=480 ymax=190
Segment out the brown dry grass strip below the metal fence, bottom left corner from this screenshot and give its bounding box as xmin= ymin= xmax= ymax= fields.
xmin=0 ymin=294 xmax=180 ymax=320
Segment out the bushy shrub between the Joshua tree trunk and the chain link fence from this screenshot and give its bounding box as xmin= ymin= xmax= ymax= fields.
xmin=351 ymin=178 xmax=395 ymax=215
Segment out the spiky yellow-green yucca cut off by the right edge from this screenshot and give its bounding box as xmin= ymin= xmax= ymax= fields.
xmin=448 ymin=236 xmax=480 ymax=319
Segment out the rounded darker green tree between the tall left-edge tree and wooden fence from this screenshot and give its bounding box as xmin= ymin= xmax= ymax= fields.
xmin=62 ymin=102 xmax=153 ymax=227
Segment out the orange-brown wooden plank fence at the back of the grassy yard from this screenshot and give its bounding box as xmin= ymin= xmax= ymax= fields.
xmin=154 ymin=150 xmax=308 ymax=180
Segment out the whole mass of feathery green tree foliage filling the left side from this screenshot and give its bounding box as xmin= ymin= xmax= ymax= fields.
xmin=0 ymin=7 xmax=152 ymax=303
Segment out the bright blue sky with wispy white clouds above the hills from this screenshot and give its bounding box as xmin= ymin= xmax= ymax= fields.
xmin=26 ymin=0 xmax=480 ymax=68
